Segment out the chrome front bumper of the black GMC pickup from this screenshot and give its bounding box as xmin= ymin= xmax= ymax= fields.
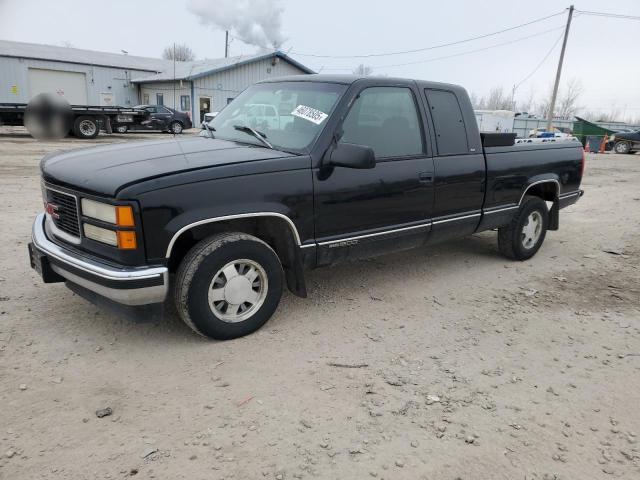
xmin=31 ymin=213 xmax=169 ymax=305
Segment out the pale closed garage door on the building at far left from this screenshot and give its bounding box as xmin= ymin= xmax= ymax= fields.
xmin=29 ymin=68 xmax=87 ymax=105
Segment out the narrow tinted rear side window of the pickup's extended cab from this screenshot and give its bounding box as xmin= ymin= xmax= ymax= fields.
xmin=425 ymin=90 xmax=469 ymax=155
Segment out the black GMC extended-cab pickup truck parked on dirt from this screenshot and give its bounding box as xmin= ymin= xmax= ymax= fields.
xmin=29 ymin=75 xmax=584 ymax=339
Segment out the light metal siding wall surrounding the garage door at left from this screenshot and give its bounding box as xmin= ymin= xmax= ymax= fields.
xmin=0 ymin=57 xmax=155 ymax=106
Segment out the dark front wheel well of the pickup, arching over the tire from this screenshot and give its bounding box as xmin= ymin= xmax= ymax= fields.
xmin=167 ymin=216 xmax=306 ymax=297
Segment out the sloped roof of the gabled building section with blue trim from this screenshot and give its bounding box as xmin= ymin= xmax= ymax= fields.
xmin=131 ymin=51 xmax=314 ymax=83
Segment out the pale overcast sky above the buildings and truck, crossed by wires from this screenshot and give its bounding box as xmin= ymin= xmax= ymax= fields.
xmin=0 ymin=0 xmax=640 ymax=118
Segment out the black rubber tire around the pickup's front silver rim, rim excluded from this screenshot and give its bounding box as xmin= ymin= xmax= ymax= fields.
xmin=174 ymin=232 xmax=283 ymax=340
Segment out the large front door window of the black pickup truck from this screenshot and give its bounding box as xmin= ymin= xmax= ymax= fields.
xmin=340 ymin=87 xmax=423 ymax=158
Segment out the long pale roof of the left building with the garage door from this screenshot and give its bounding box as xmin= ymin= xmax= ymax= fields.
xmin=0 ymin=40 xmax=173 ymax=72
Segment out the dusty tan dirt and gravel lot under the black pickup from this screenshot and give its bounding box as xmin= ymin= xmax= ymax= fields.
xmin=0 ymin=130 xmax=640 ymax=480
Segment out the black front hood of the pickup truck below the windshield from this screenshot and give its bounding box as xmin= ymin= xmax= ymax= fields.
xmin=40 ymin=137 xmax=291 ymax=197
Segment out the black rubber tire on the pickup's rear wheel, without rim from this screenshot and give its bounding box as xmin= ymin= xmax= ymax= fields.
xmin=498 ymin=196 xmax=549 ymax=260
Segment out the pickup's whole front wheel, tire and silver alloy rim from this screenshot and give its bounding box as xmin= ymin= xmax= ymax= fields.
xmin=174 ymin=233 xmax=283 ymax=340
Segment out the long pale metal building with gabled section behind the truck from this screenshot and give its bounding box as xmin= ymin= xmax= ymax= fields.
xmin=0 ymin=40 xmax=313 ymax=126
